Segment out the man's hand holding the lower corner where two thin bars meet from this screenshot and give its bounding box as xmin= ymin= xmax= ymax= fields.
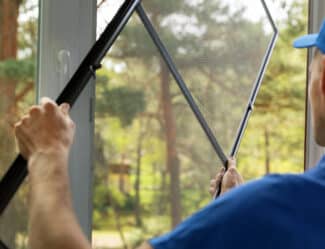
xmin=209 ymin=159 xmax=244 ymax=197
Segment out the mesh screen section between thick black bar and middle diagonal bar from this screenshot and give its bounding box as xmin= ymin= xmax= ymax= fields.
xmin=93 ymin=13 xmax=218 ymax=248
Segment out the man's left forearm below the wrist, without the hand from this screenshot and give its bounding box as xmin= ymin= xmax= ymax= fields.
xmin=29 ymin=151 xmax=90 ymax=249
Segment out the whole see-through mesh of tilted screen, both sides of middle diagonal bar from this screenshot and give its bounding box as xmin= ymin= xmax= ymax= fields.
xmin=93 ymin=0 xmax=273 ymax=249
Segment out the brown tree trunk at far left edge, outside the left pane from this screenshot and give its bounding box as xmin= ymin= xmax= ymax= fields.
xmin=0 ymin=0 xmax=26 ymax=248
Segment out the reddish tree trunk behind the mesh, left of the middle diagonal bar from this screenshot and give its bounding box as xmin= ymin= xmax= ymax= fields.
xmin=160 ymin=61 xmax=181 ymax=227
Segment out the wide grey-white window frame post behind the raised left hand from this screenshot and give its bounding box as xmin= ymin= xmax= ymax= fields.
xmin=37 ymin=0 xmax=96 ymax=239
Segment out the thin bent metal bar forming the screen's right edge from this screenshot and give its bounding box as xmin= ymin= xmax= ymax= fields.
xmin=230 ymin=0 xmax=279 ymax=157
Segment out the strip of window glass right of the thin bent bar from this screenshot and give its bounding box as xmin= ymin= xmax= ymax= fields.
xmin=238 ymin=0 xmax=309 ymax=177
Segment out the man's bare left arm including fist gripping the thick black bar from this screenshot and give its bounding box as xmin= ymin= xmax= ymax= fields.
xmin=16 ymin=99 xmax=91 ymax=249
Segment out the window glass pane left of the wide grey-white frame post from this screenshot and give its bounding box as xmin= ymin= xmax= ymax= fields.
xmin=0 ymin=0 xmax=38 ymax=248
